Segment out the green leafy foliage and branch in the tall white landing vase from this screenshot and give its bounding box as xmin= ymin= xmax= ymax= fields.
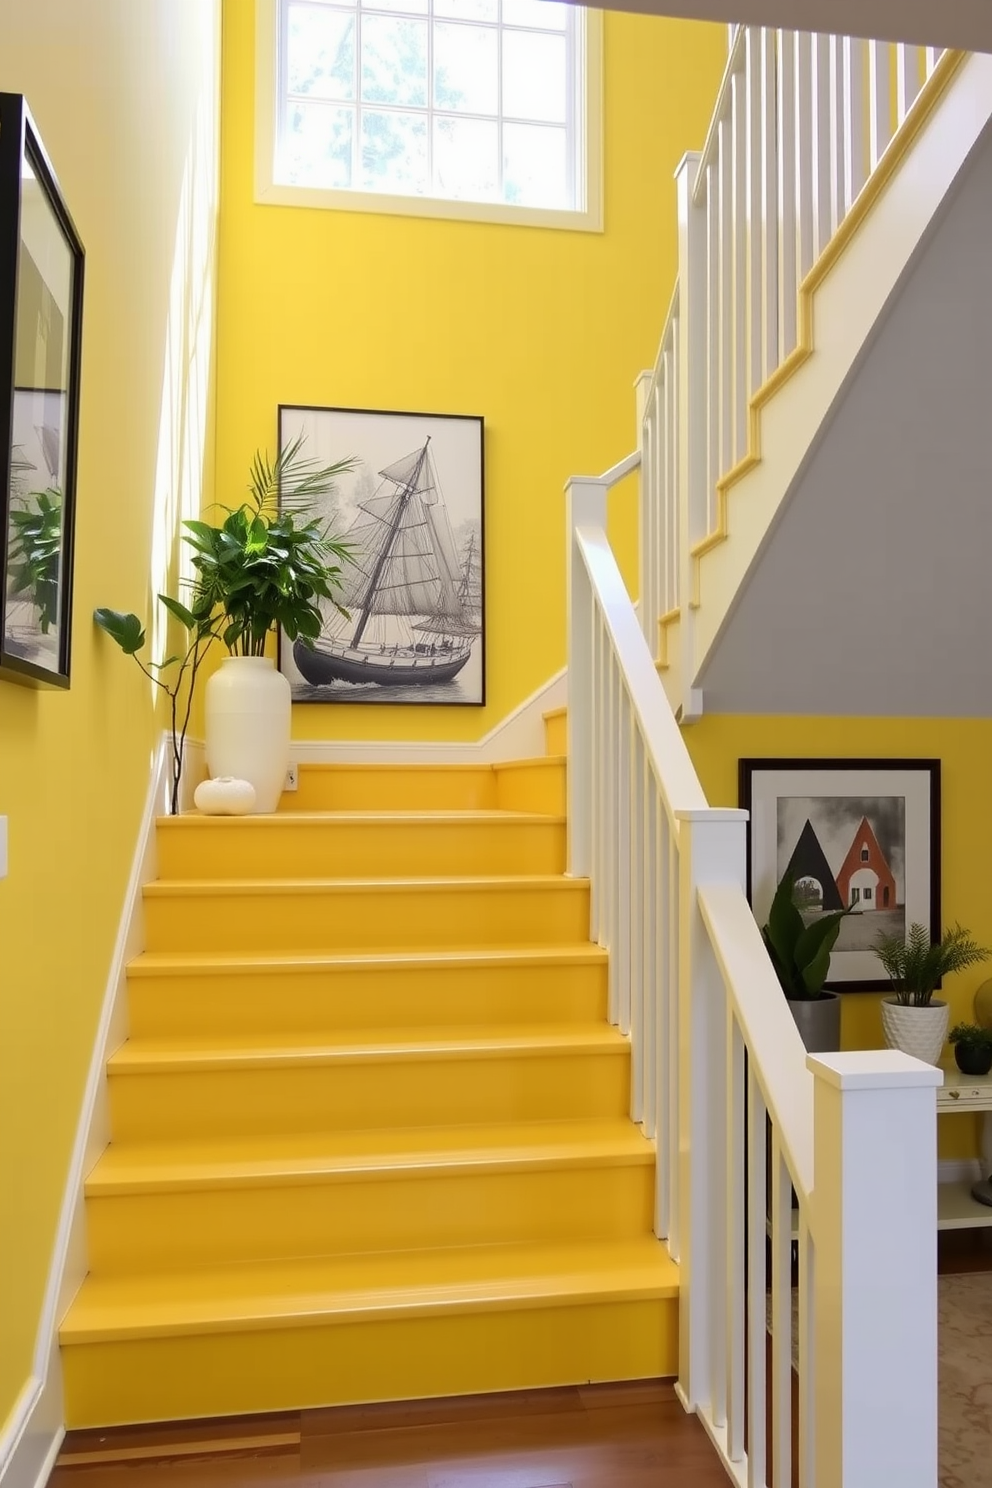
xmin=94 ymin=436 xmax=355 ymax=815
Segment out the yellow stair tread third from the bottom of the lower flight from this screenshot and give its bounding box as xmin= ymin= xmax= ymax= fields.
xmin=107 ymin=1024 xmax=628 ymax=1073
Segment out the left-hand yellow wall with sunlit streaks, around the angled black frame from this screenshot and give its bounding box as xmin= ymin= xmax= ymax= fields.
xmin=0 ymin=0 xmax=217 ymax=1434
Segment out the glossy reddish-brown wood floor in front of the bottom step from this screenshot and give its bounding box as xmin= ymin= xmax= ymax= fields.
xmin=49 ymin=1381 xmax=727 ymax=1488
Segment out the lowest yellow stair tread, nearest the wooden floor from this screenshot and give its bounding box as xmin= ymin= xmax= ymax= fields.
xmin=59 ymin=1237 xmax=678 ymax=1345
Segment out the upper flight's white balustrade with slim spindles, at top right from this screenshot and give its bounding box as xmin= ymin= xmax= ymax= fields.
xmin=638 ymin=27 xmax=941 ymax=681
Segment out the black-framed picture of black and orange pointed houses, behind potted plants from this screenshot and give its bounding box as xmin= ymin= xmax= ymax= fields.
xmin=738 ymin=759 xmax=941 ymax=992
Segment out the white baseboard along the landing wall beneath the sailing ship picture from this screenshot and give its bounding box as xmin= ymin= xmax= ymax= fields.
xmin=183 ymin=670 xmax=568 ymax=773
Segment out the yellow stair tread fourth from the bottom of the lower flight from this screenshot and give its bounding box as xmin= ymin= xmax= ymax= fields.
xmin=128 ymin=940 xmax=607 ymax=976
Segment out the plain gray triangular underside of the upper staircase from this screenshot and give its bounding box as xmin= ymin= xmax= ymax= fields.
xmin=699 ymin=116 xmax=992 ymax=717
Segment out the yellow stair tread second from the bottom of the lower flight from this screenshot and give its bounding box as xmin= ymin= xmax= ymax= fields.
xmin=86 ymin=1119 xmax=654 ymax=1198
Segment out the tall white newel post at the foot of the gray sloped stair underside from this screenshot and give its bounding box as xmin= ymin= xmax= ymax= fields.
xmin=675 ymin=153 xmax=709 ymax=723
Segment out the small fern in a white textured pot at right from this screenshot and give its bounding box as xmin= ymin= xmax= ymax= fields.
xmin=873 ymin=924 xmax=992 ymax=1064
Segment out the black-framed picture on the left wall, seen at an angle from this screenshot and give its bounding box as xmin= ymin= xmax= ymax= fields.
xmin=0 ymin=94 xmax=83 ymax=687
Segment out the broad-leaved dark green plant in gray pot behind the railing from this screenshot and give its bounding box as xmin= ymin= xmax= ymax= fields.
xmin=761 ymin=875 xmax=851 ymax=1054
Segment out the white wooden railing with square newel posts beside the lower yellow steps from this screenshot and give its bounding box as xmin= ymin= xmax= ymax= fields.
xmin=567 ymin=454 xmax=940 ymax=1488
